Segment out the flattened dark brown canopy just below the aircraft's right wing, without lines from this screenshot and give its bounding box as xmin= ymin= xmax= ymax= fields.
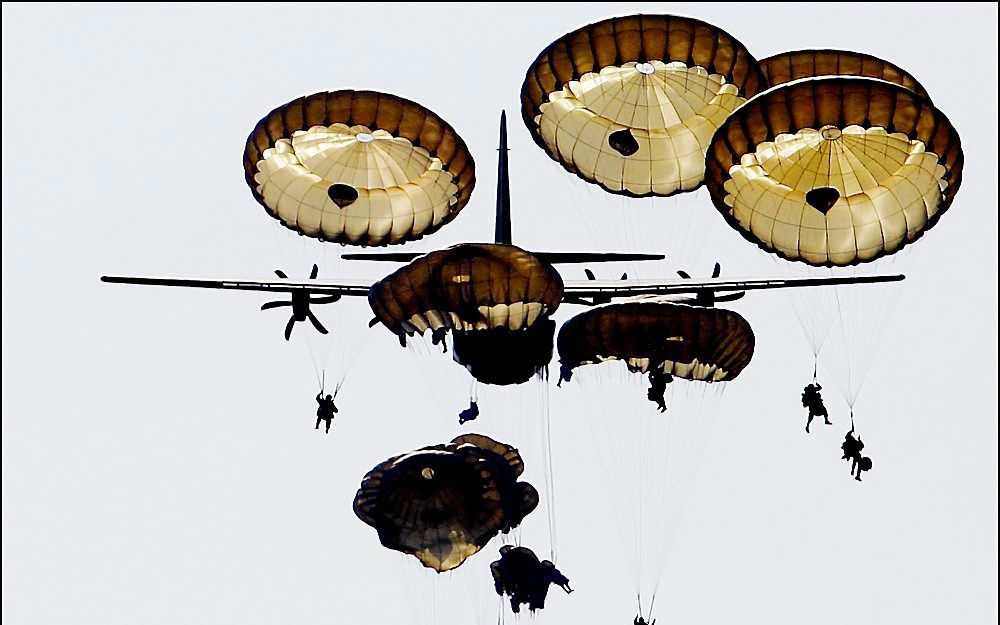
xmin=558 ymin=300 xmax=754 ymax=382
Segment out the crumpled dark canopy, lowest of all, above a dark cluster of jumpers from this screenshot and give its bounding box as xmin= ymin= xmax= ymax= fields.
xmin=354 ymin=434 xmax=538 ymax=573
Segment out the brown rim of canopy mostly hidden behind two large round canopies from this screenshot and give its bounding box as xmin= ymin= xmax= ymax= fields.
xmin=760 ymin=50 xmax=930 ymax=100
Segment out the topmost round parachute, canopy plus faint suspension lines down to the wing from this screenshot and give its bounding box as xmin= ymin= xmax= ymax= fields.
xmin=521 ymin=15 xmax=767 ymax=277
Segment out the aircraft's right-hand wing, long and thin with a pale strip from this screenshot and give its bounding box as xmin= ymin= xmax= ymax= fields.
xmin=564 ymin=275 xmax=906 ymax=300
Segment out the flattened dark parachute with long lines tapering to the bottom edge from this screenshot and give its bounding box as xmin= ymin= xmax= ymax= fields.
xmin=557 ymin=298 xmax=754 ymax=622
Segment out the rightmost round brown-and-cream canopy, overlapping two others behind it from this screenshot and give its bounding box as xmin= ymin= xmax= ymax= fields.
xmin=706 ymin=78 xmax=963 ymax=266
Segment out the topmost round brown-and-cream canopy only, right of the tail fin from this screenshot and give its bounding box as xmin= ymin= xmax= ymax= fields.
xmin=521 ymin=15 xmax=766 ymax=197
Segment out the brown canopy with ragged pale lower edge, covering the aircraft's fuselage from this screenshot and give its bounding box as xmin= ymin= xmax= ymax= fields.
xmin=368 ymin=243 xmax=563 ymax=335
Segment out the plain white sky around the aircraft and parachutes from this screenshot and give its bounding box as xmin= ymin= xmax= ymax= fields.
xmin=3 ymin=3 xmax=998 ymax=625
